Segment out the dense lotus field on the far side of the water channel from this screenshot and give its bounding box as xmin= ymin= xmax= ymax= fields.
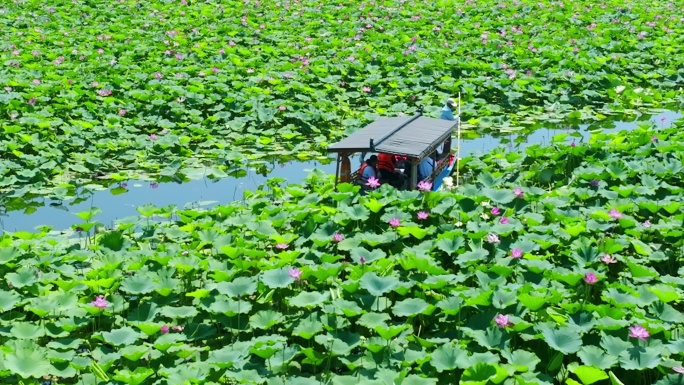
xmin=0 ymin=0 xmax=684 ymax=197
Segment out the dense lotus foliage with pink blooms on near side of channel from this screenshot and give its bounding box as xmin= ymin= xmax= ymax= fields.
xmin=0 ymin=115 xmax=684 ymax=385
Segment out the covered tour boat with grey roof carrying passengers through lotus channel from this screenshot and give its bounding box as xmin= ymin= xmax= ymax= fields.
xmin=328 ymin=97 xmax=461 ymax=191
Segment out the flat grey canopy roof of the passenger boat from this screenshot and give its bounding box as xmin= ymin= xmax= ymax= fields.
xmin=328 ymin=114 xmax=458 ymax=159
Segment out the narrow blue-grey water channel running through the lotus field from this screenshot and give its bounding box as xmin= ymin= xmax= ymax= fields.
xmin=0 ymin=111 xmax=682 ymax=232
